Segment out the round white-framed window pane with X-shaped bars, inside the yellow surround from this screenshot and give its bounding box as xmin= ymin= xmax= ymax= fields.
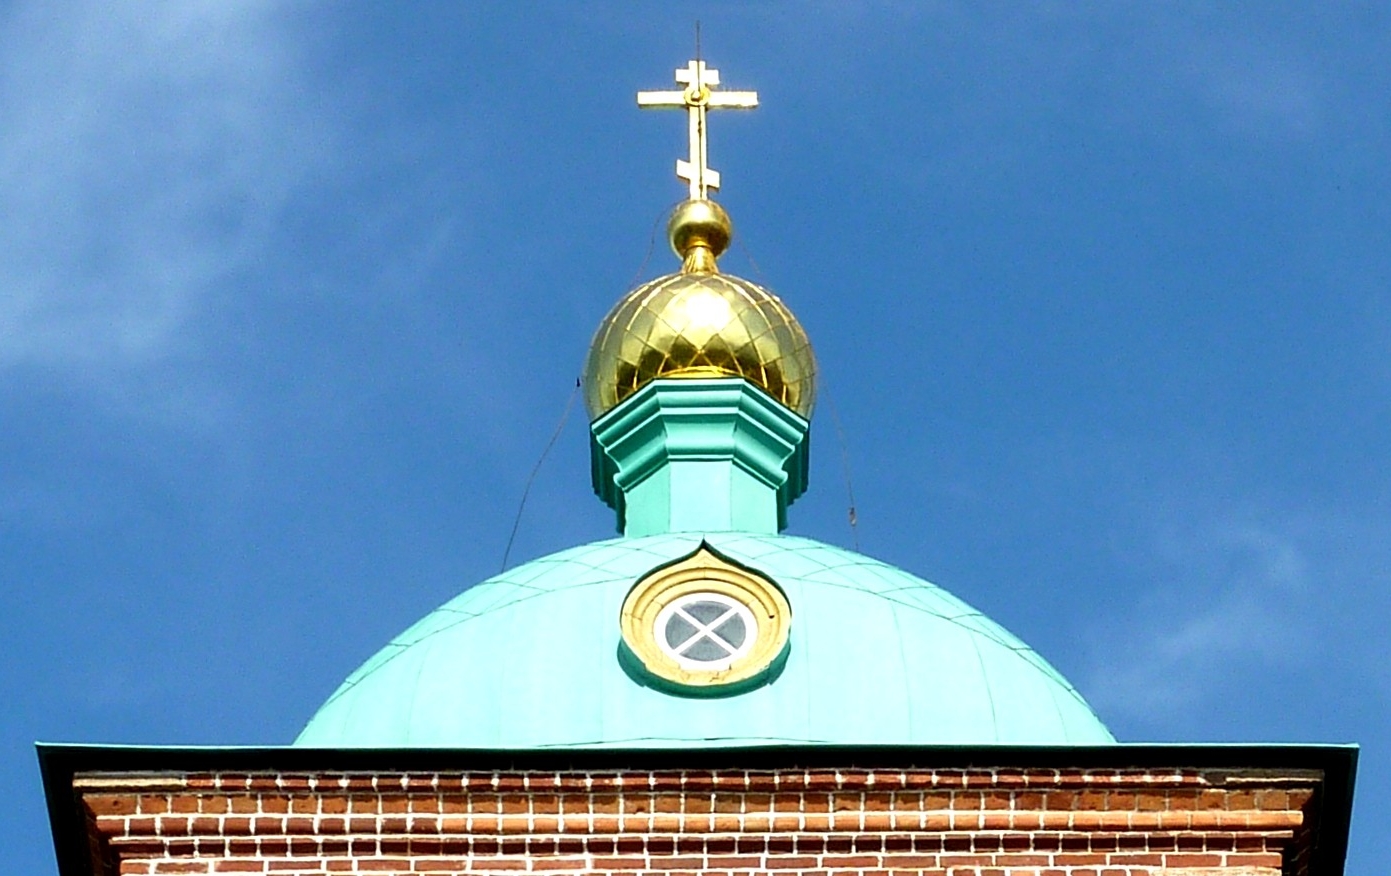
xmin=652 ymin=592 xmax=758 ymax=669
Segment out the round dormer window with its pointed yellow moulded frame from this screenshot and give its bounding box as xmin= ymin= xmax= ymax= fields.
xmin=620 ymin=544 xmax=791 ymax=692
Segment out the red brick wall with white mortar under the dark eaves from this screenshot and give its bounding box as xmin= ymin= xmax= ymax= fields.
xmin=74 ymin=769 xmax=1319 ymax=876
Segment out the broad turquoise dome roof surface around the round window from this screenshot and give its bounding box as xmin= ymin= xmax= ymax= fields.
xmin=295 ymin=533 xmax=1114 ymax=748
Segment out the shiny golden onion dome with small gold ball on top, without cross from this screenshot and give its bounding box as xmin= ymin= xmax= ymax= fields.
xmin=584 ymin=200 xmax=817 ymax=420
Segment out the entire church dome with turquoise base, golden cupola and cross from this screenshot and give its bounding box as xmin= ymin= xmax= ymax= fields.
xmin=296 ymin=58 xmax=1114 ymax=749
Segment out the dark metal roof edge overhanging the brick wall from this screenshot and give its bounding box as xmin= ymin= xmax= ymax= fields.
xmin=36 ymin=743 xmax=1360 ymax=876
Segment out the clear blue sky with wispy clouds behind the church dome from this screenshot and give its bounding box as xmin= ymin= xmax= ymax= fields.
xmin=0 ymin=1 xmax=1391 ymax=873
